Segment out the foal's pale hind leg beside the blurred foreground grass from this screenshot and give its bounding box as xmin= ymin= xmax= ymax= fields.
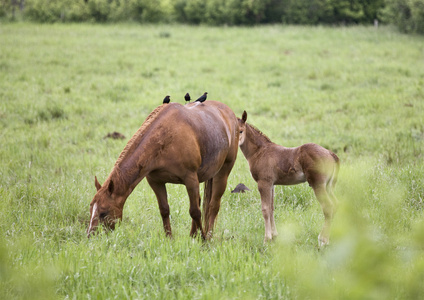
xmin=312 ymin=183 xmax=335 ymax=248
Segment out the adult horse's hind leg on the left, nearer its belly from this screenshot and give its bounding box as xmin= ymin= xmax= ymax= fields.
xmin=184 ymin=173 xmax=205 ymax=239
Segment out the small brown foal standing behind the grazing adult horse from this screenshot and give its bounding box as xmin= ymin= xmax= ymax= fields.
xmin=239 ymin=111 xmax=340 ymax=247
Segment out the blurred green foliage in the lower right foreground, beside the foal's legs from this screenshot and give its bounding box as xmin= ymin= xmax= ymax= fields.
xmin=273 ymin=161 xmax=424 ymax=299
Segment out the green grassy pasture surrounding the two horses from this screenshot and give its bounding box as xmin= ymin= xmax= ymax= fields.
xmin=0 ymin=24 xmax=424 ymax=299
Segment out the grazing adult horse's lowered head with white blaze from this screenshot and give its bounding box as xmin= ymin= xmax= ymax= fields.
xmin=87 ymin=177 xmax=123 ymax=237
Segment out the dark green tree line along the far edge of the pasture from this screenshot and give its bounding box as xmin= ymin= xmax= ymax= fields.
xmin=0 ymin=0 xmax=424 ymax=34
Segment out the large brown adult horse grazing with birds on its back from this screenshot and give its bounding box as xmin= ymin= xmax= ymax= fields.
xmin=87 ymin=101 xmax=239 ymax=239
